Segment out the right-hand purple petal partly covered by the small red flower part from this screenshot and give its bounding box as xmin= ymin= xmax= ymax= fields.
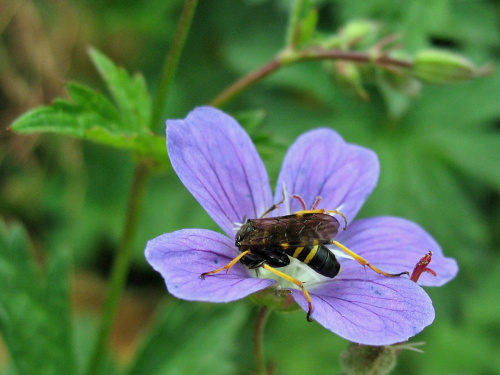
xmin=337 ymin=216 xmax=458 ymax=286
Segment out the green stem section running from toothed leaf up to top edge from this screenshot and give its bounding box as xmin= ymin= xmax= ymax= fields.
xmin=151 ymin=0 xmax=198 ymax=127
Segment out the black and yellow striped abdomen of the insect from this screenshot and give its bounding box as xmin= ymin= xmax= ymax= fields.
xmin=285 ymin=244 xmax=340 ymax=278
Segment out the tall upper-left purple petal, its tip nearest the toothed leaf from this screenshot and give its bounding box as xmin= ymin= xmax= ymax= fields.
xmin=167 ymin=107 xmax=272 ymax=238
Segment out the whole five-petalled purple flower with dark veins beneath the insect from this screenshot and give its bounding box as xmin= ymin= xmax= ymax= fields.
xmin=145 ymin=107 xmax=458 ymax=345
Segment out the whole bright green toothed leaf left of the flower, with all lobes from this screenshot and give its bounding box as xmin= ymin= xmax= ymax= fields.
xmin=10 ymin=49 xmax=166 ymax=166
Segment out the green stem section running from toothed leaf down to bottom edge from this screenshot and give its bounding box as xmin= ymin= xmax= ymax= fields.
xmin=87 ymin=163 xmax=150 ymax=375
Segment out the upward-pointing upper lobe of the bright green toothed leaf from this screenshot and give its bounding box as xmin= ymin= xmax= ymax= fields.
xmin=89 ymin=48 xmax=151 ymax=130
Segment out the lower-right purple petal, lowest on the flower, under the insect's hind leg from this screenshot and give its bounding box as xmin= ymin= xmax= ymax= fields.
xmin=292 ymin=269 xmax=434 ymax=345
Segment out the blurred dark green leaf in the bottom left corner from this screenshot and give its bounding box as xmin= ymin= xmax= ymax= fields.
xmin=0 ymin=221 xmax=78 ymax=375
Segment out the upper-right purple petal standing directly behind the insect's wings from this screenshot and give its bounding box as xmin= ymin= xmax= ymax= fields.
xmin=275 ymin=129 xmax=380 ymax=222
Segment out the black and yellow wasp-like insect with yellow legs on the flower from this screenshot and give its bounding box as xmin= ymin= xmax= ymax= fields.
xmin=200 ymin=195 xmax=409 ymax=321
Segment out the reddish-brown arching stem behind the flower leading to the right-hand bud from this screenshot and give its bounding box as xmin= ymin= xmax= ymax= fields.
xmin=210 ymin=47 xmax=413 ymax=107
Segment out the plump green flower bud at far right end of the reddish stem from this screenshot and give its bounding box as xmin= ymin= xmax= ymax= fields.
xmin=413 ymin=49 xmax=477 ymax=85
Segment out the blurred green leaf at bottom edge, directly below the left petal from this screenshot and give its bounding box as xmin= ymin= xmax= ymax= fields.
xmin=127 ymin=301 xmax=249 ymax=375
